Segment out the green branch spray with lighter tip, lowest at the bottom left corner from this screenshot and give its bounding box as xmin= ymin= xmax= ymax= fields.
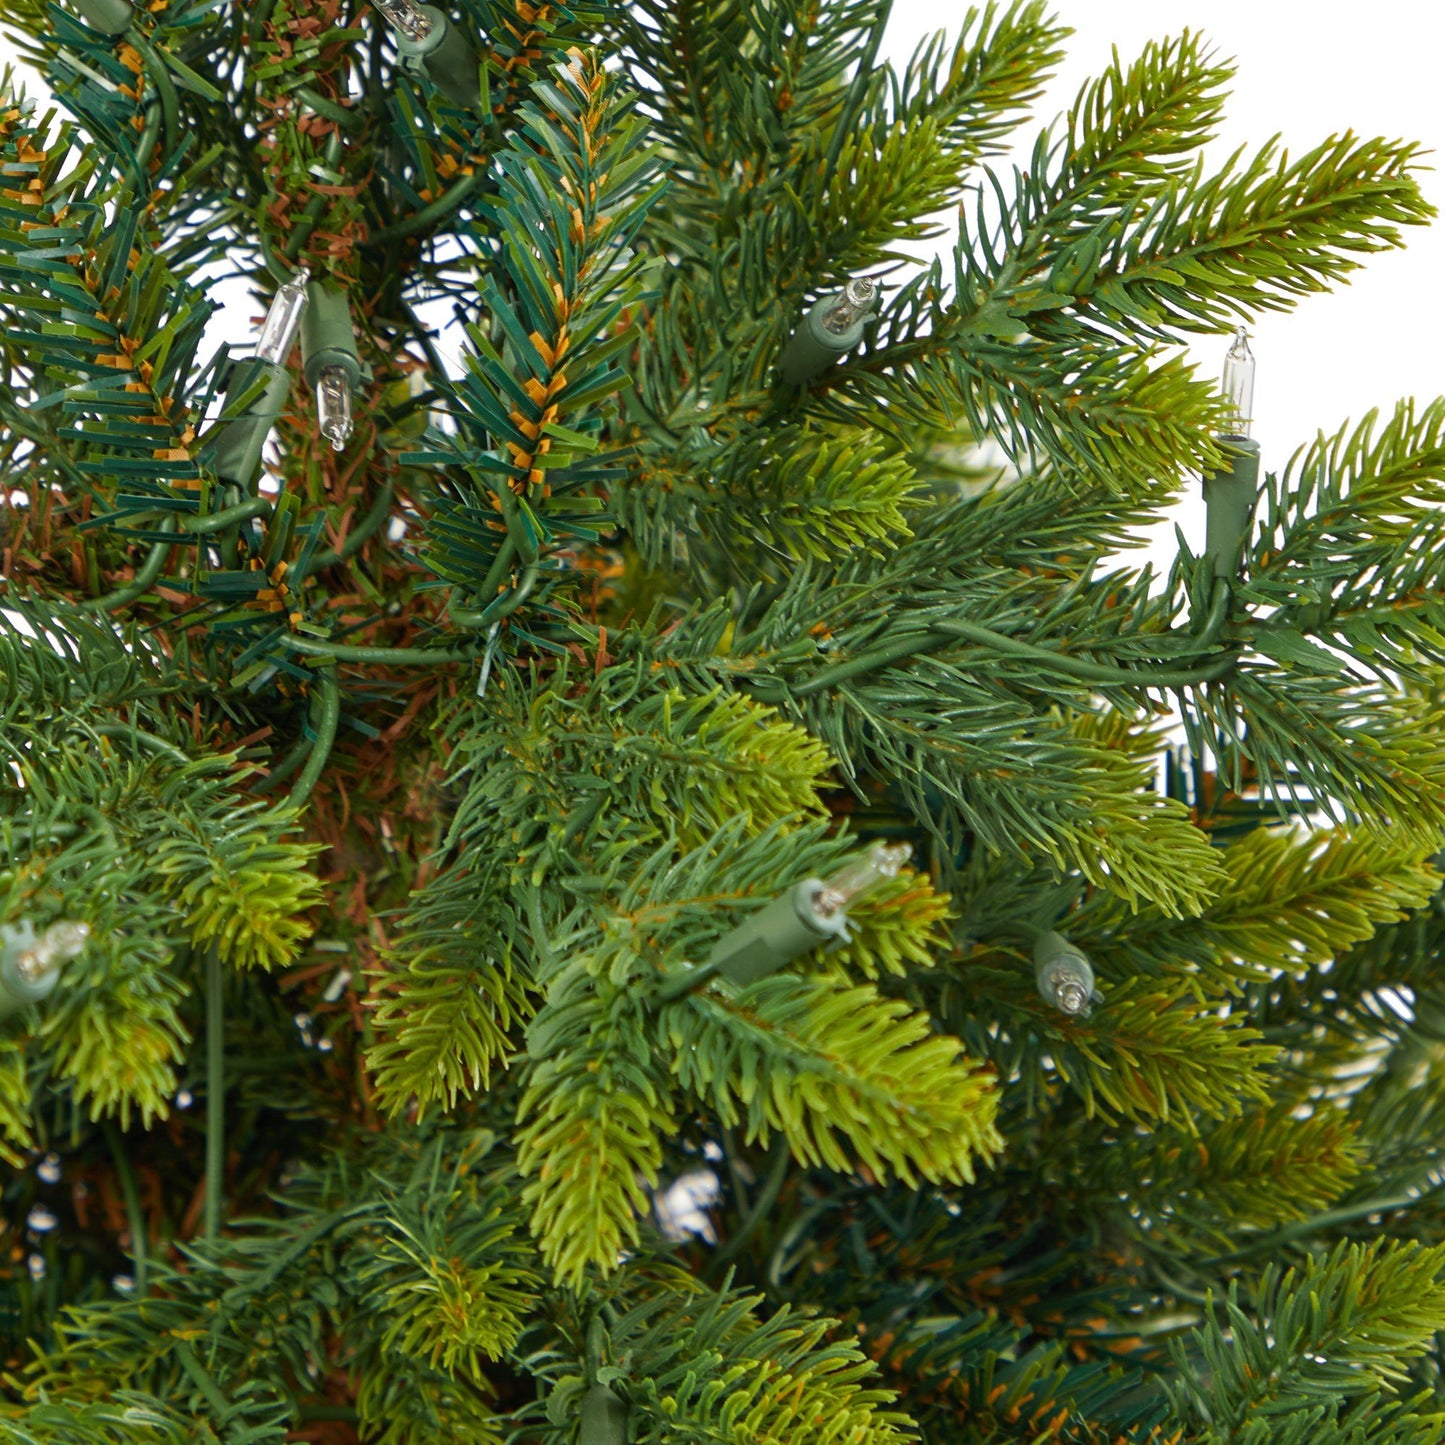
xmin=15 ymin=1131 xmax=525 ymax=1445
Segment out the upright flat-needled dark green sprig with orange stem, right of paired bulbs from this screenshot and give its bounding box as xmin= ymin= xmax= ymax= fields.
xmin=402 ymin=52 xmax=659 ymax=621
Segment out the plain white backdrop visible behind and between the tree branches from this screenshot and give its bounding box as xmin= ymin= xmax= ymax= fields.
xmin=0 ymin=0 xmax=1445 ymax=537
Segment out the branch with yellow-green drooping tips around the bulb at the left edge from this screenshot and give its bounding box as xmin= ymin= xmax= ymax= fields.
xmin=0 ymin=598 xmax=319 ymax=1124
